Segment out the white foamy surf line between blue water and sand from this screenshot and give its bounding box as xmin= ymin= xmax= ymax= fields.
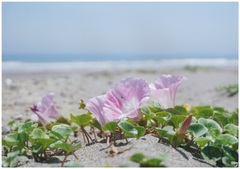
xmin=2 ymin=58 xmax=238 ymax=72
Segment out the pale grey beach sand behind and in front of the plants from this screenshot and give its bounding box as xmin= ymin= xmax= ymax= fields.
xmin=2 ymin=67 xmax=238 ymax=167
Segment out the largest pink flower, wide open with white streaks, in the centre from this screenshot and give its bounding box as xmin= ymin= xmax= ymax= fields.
xmin=103 ymin=77 xmax=150 ymax=121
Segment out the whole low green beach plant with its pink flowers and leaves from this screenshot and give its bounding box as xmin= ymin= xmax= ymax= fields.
xmin=2 ymin=75 xmax=238 ymax=167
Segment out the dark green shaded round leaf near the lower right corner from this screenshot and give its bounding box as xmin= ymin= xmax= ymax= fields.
xmin=201 ymin=146 xmax=223 ymax=163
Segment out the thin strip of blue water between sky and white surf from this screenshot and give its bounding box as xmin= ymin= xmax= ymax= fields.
xmin=2 ymin=54 xmax=238 ymax=63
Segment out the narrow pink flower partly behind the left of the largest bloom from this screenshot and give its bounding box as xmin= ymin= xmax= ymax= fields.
xmin=86 ymin=95 xmax=108 ymax=126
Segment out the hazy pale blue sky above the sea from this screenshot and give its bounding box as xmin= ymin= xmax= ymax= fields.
xmin=2 ymin=2 xmax=238 ymax=57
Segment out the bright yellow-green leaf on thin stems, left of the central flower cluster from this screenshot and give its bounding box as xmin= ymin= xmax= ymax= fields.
xmin=70 ymin=113 xmax=92 ymax=126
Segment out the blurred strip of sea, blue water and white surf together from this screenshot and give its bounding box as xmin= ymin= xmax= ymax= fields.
xmin=2 ymin=54 xmax=238 ymax=73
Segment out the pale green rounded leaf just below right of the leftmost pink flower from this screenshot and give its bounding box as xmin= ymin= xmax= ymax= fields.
xmin=52 ymin=124 xmax=74 ymax=138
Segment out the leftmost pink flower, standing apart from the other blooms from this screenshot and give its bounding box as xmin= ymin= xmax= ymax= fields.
xmin=30 ymin=92 xmax=59 ymax=126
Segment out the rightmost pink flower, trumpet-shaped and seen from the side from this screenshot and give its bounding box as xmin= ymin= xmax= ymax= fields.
xmin=149 ymin=75 xmax=187 ymax=109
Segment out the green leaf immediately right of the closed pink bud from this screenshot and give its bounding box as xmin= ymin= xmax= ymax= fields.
xmin=187 ymin=123 xmax=208 ymax=138
